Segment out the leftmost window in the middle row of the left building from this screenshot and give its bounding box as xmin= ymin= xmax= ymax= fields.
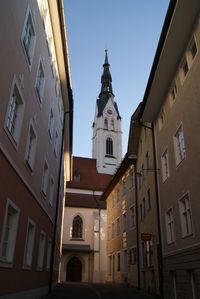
xmin=5 ymin=79 xmax=24 ymax=144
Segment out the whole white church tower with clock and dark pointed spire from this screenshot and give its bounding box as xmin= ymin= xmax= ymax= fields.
xmin=92 ymin=50 xmax=122 ymax=174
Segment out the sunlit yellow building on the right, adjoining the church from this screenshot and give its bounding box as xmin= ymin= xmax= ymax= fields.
xmin=101 ymin=155 xmax=137 ymax=286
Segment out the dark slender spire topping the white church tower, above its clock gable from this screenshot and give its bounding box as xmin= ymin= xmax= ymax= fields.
xmin=99 ymin=49 xmax=113 ymax=97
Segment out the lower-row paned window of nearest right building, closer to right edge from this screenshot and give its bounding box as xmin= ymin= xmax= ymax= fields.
xmin=179 ymin=194 xmax=192 ymax=237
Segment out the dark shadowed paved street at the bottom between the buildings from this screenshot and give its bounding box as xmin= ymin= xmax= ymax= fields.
xmin=45 ymin=283 xmax=157 ymax=299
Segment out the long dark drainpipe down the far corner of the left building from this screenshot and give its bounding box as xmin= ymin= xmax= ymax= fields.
xmin=49 ymin=111 xmax=72 ymax=294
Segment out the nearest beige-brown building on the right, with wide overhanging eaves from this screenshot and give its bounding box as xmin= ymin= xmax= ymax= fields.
xmin=142 ymin=1 xmax=200 ymax=299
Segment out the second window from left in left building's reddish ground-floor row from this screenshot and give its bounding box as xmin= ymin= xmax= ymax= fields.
xmin=24 ymin=220 xmax=35 ymax=267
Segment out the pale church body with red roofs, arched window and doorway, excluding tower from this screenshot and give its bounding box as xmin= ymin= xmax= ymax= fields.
xmin=60 ymin=157 xmax=111 ymax=282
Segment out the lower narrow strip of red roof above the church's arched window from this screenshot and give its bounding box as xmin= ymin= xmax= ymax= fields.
xmin=65 ymin=193 xmax=106 ymax=209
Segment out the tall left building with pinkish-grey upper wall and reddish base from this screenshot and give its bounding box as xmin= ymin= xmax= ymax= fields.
xmin=0 ymin=0 xmax=73 ymax=298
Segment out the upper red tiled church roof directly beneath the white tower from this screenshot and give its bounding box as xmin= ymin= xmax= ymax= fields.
xmin=67 ymin=157 xmax=112 ymax=191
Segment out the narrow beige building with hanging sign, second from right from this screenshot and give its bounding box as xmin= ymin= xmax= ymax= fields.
xmin=128 ymin=108 xmax=162 ymax=294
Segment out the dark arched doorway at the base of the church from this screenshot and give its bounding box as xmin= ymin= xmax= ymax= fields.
xmin=66 ymin=257 xmax=82 ymax=281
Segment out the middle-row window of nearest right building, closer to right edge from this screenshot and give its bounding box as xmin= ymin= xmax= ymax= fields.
xmin=174 ymin=125 xmax=185 ymax=166
